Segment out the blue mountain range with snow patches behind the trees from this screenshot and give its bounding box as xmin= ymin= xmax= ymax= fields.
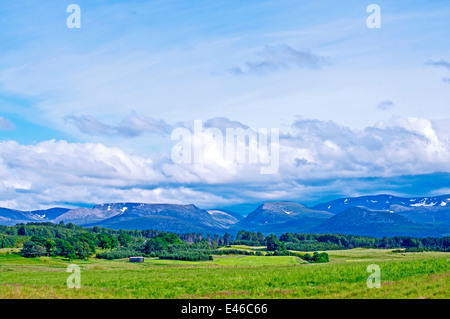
xmin=0 ymin=195 xmax=450 ymax=237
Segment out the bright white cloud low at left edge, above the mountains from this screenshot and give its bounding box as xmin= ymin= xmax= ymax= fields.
xmin=0 ymin=140 xmax=164 ymax=205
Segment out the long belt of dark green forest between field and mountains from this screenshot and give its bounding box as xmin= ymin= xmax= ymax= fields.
xmin=0 ymin=222 xmax=450 ymax=262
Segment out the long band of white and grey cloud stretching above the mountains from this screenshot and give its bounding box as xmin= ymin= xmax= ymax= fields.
xmin=0 ymin=118 xmax=450 ymax=209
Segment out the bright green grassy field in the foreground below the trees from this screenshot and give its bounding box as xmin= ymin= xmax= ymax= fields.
xmin=0 ymin=246 xmax=450 ymax=299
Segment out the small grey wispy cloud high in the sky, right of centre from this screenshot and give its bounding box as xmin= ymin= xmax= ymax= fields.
xmin=229 ymin=44 xmax=326 ymax=75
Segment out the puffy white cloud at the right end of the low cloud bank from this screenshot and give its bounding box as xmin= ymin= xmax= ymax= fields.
xmin=289 ymin=118 xmax=450 ymax=177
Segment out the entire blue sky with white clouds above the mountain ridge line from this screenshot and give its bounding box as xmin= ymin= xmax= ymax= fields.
xmin=0 ymin=0 xmax=450 ymax=211
